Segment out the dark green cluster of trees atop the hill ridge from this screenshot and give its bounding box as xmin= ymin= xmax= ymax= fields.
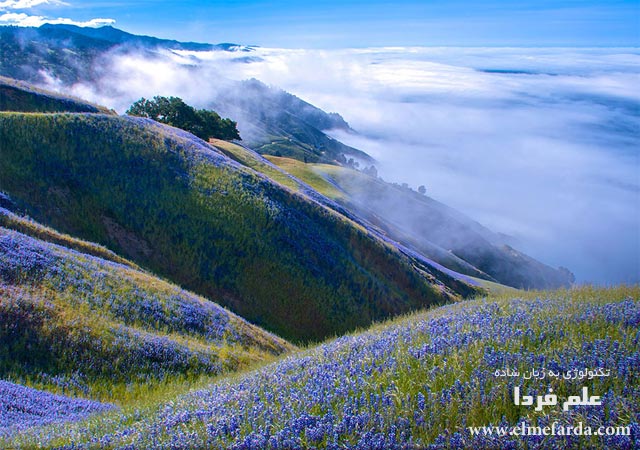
xmin=127 ymin=96 xmax=240 ymax=140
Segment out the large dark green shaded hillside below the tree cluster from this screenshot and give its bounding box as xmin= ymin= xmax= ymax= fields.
xmin=0 ymin=113 xmax=460 ymax=340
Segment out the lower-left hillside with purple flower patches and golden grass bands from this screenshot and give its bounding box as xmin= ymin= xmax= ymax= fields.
xmin=0 ymin=227 xmax=292 ymax=401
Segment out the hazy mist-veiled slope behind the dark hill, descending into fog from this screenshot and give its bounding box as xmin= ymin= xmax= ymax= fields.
xmin=262 ymin=157 xmax=573 ymax=289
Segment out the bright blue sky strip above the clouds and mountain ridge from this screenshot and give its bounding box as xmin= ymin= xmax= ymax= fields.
xmin=0 ymin=0 xmax=640 ymax=48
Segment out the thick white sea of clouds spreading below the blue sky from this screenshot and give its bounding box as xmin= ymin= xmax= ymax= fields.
xmin=57 ymin=48 xmax=640 ymax=284
